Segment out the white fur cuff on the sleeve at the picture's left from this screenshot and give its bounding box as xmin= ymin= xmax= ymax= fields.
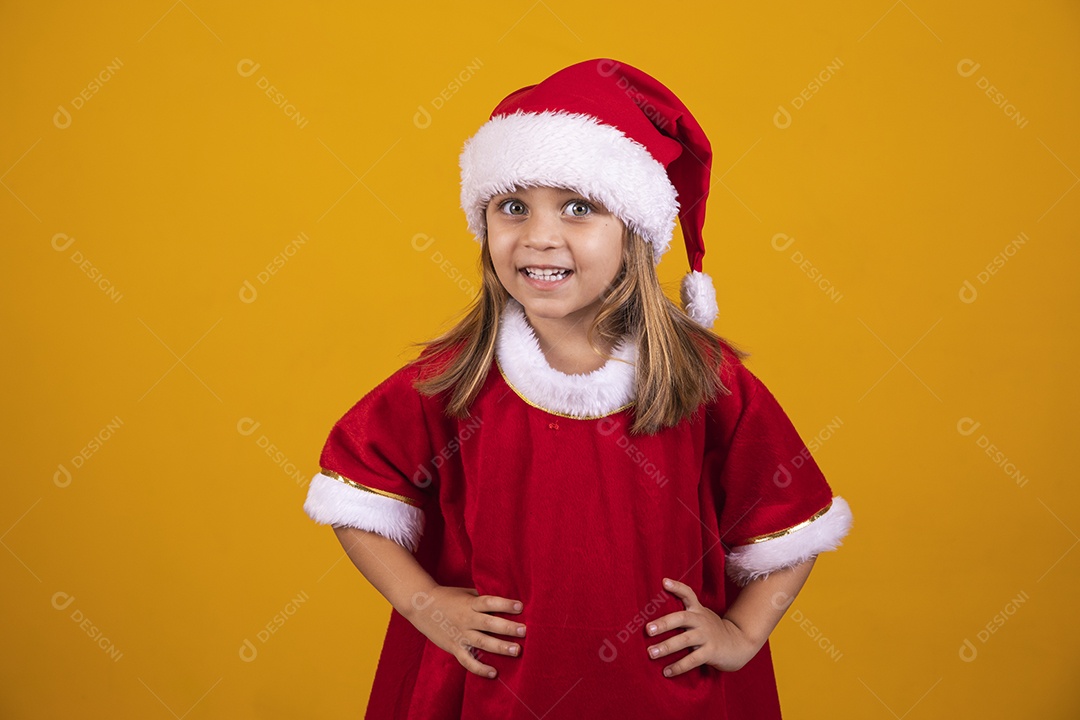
xmin=303 ymin=473 xmax=423 ymax=553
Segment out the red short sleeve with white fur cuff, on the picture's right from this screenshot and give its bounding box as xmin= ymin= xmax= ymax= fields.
xmin=710 ymin=361 xmax=851 ymax=585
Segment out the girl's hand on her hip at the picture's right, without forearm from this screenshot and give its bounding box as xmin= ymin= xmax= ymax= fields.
xmin=646 ymin=578 xmax=764 ymax=678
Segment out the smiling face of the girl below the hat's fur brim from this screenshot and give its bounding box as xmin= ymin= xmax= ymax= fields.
xmin=486 ymin=187 xmax=624 ymax=329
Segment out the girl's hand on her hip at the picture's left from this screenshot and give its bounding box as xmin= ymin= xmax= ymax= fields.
xmin=407 ymin=585 xmax=525 ymax=678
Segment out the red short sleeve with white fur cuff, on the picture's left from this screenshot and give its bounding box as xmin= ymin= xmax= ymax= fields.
xmin=303 ymin=367 xmax=432 ymax=552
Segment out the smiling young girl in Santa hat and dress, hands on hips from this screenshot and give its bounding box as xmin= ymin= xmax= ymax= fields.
xmin=305 ymin=59 xmax=851 ymax=720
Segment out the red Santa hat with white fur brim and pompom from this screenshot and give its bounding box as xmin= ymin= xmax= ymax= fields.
xmin=460 ymin=58 xmax=717 ymax=327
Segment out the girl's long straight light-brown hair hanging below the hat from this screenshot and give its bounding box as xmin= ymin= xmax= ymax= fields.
xmin=414 ymin=229 xmax=750 ymax=434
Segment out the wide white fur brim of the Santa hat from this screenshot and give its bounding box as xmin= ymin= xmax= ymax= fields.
xmin=459 ymin=110 xmax=678 ymax=260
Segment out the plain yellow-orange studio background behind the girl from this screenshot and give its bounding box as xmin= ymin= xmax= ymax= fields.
xmin=0 ymin=0 xmax=1080 ymax=720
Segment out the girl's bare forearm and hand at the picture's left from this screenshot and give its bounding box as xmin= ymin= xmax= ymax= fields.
xmin=334 ymin=527 xmax=525 ymax=678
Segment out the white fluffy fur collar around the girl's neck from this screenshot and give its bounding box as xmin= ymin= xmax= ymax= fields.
xmin=495 ymin=298 xmax=637 ymax=419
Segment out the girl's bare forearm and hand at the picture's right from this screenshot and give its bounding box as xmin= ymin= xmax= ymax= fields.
xmin=646 ymin=557 xmax=816 ymax=677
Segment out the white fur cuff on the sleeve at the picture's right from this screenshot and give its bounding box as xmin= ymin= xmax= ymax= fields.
xmin=727 ymin=497 xmax=851 ymax=585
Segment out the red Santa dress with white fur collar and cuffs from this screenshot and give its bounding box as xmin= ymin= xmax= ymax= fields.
xmin=305 ymin=300 xmax=851 ymax=720
